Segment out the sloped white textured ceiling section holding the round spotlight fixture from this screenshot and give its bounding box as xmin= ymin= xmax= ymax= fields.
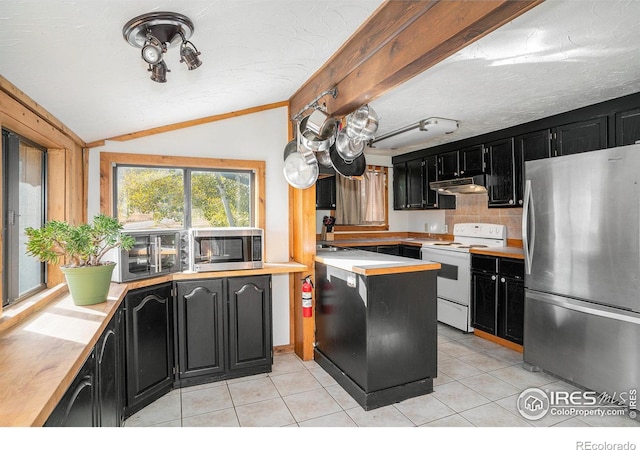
xmin=0 ymin=0 xmax=382 ymax=142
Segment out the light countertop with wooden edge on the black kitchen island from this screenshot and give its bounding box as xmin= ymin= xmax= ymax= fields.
xmin=316 ymin=249 xmax=440 ymax=276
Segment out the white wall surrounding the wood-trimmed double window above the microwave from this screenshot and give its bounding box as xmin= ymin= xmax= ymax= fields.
xmin=87 ymin=108 xmax=289 ymax=346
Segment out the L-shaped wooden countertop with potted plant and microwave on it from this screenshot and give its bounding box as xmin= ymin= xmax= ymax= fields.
xmin=0 ymin=262 xmax=306 ymax=427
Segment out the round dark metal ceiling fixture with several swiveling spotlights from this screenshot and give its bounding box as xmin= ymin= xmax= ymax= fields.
xmin=122 ymin=11 xmax=202 ymax=83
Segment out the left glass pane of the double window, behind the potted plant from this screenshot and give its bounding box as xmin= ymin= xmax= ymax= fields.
xmin=116 ymin=166 xmax=184 ymax=229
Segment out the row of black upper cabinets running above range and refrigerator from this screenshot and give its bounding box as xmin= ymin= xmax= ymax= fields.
xmin=392 ymin=93 xmax=640 ymax=209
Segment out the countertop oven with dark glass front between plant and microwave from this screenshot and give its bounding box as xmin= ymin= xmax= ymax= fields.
xmin=105 ymin=230 xmax=187 ymax=283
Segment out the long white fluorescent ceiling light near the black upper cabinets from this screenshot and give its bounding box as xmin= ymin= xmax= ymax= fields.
xmin=371 ymin=117 xmax=458 ymax=150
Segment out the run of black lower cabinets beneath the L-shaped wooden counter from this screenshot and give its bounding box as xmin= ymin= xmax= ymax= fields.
xmin=45 ymin=275 xmax=273 ymax=427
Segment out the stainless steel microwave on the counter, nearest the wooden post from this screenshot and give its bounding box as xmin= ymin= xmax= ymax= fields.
xmin=187 ymin=227 xmax=264 ymax=272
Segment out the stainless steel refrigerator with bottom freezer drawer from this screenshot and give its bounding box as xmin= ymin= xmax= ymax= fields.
xmin=522 ymin=144 xmax=640 ymax=394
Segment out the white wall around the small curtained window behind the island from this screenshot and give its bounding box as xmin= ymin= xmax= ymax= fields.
xmin=316 ymin=151 xmax=445 ymax=234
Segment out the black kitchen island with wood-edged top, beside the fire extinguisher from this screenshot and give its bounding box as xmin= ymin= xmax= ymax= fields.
xmin=314 ymin=248 xmax=440 ymax=410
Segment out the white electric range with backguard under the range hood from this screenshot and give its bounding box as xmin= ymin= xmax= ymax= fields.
xmin=421 ymin=223 xmax=507 ymax=333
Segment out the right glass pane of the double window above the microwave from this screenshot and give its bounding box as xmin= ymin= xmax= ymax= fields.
xmin=191 ymin=170 xmax=252 ymax=228
